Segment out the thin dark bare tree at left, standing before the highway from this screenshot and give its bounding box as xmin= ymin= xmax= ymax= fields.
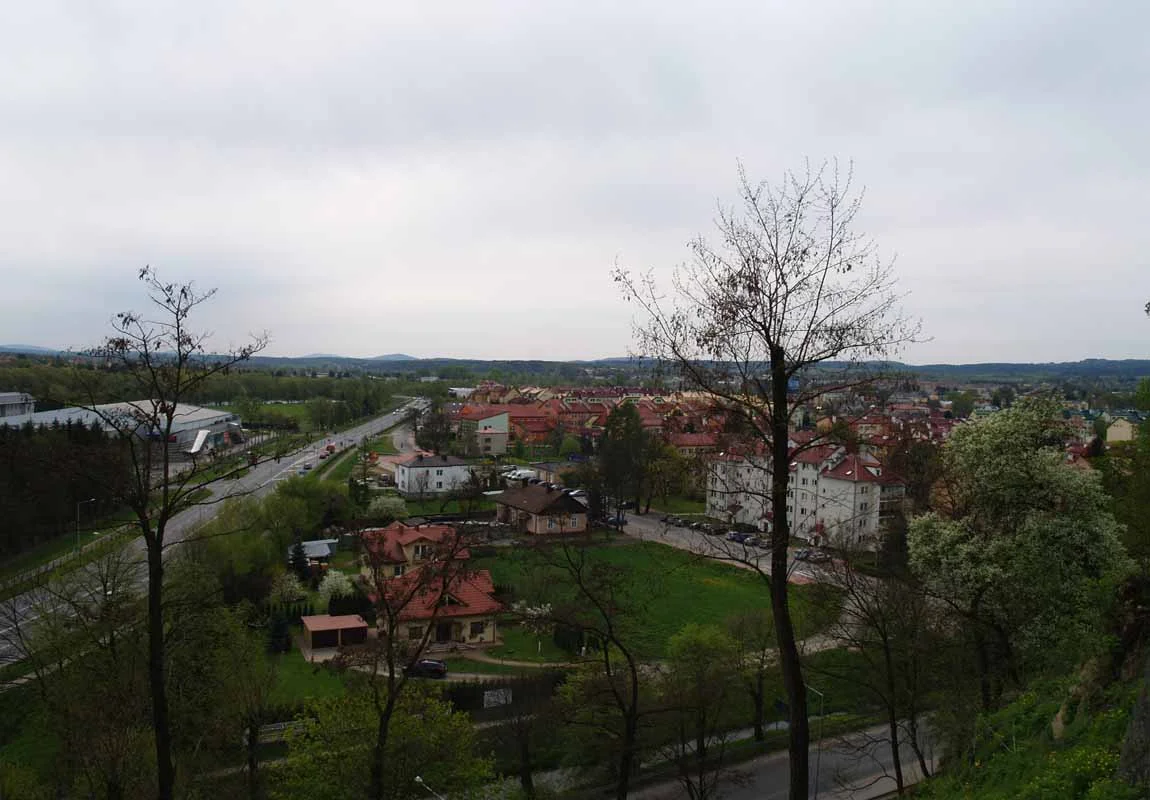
xmin=81 ymin=267 xmax=268 ymax=800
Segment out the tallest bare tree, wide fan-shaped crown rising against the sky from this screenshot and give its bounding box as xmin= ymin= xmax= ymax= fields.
xmin=615 ymin=159 xmax=918 ymax=800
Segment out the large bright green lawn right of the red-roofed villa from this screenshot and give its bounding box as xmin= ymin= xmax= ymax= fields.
xmin=473 ymin=540 xmax=838 ymax=659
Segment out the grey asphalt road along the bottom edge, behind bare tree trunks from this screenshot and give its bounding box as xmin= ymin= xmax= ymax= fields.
xmin=629 ymin=725 xmax=934 ymax=800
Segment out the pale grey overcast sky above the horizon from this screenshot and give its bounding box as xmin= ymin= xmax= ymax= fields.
xmin=0 ymin=0 xmax=1150 ymax=363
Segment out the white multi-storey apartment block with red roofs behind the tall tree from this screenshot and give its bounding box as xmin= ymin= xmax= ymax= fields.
xmin=707 ymin=444 xmax=905 ymax=547
